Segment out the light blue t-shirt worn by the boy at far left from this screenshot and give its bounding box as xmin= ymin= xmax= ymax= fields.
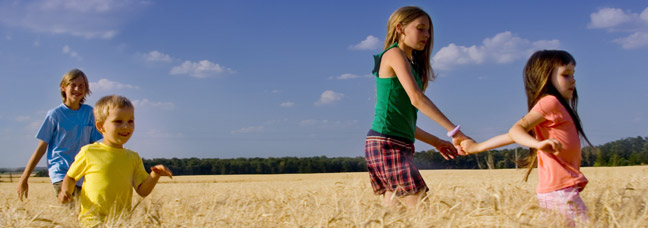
xmin=36 ymin=104 xmax=103 ymax=186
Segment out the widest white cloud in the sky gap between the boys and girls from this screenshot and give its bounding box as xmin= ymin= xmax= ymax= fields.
xmin=169 ymin=60 xmax=235 ymax=78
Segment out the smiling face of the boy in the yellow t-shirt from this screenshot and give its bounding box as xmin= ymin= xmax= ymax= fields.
xmin=97 ymin=108 xmax=135 ymax=148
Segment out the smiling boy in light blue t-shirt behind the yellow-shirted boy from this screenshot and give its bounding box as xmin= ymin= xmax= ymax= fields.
xmin=16 ymin=69 xmax=102 ymax=201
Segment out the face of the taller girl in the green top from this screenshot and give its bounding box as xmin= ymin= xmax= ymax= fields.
xmin=401 ymin=16 xmax=432 ymax=51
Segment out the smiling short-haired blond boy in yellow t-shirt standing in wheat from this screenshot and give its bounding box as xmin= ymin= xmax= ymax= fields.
xmin=58 ymin=95 xmax=172 ymax=226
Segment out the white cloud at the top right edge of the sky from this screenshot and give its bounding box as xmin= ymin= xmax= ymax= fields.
xmin=588 ymin=7 xmax=648 ymax=49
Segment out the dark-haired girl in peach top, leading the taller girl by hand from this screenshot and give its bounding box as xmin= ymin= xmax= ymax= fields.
xmin=461 ymin=50 xmax=591 ymax=226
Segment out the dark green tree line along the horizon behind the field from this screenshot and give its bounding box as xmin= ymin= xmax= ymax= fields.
xmin=0 ymin=136 xmax=648 ymax=176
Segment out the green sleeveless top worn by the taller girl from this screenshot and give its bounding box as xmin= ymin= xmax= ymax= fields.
xmin=371 ymin=43 xmax=423 ymax=142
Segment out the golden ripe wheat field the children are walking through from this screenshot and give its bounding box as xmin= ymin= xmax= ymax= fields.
xmin=0 ymin=166 xmax=648 ymax=227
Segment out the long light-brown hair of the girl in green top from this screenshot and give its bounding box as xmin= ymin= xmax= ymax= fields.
xmin=383 ymin=6 xmax=436 ymax=90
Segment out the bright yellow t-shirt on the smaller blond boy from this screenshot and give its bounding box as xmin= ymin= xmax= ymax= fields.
xmin=67 ymin=143 xmax=149 ymax=226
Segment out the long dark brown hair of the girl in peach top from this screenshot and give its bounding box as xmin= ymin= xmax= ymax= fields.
xmin=524 ymin=50 xmax=594 ymax=181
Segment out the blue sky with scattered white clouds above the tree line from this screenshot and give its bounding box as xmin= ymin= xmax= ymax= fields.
xmin=0 ymin=0 xmax=648 ymax=167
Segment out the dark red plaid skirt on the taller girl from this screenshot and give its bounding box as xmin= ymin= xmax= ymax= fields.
xmin=365 ymin=136 xmax=428 ymax=196
